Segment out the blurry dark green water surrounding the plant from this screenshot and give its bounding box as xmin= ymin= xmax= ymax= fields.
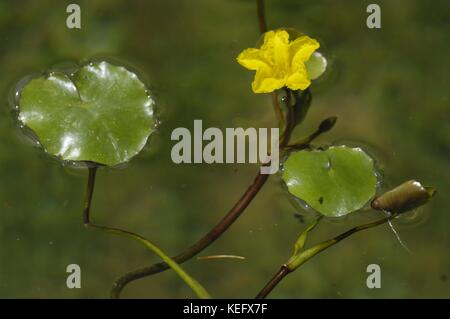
xmin=0 ymin=0 xmax=450 ymax=298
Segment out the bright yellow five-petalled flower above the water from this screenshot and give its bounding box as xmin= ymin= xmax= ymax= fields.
xmin=237 ymin=30 xmax=320 ymax=93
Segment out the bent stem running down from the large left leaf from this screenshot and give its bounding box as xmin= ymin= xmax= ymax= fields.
xmin=83 ymin=167 xmax=211 ymax=299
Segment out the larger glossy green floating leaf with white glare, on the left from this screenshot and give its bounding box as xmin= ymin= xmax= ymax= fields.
xmin=18 ymin=61 xmax=154 ymax=166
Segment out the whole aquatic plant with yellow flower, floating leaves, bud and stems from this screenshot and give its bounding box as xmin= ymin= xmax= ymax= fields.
xmin=16 ymin=0 xmax=435 ymax=298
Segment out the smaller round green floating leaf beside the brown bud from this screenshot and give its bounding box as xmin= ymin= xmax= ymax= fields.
xmin=282 ymin=146 xmax=377 ymax=217
